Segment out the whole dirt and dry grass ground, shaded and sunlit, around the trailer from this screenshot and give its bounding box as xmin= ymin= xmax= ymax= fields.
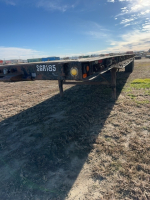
xmin=0 ymin=59 xmax=150 ymax=200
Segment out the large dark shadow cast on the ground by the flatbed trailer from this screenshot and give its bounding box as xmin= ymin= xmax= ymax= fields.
xmin=0 ymin=72 xmax=129 ymax=200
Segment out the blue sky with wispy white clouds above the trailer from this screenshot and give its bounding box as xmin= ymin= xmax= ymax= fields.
xmin=0 ymin=0 xmax=150 ymax=60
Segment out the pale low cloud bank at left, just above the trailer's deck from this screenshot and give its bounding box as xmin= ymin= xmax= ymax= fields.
xmin=0 ymin=46 xmax=42 ymax=60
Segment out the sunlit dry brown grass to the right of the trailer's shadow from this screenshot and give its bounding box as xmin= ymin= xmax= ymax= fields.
xmin=88 ymin=60 xmax=150 ymax=199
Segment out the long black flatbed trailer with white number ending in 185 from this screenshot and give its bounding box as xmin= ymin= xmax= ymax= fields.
xmin=0 ymin=54 xmax=134 ymax=99
